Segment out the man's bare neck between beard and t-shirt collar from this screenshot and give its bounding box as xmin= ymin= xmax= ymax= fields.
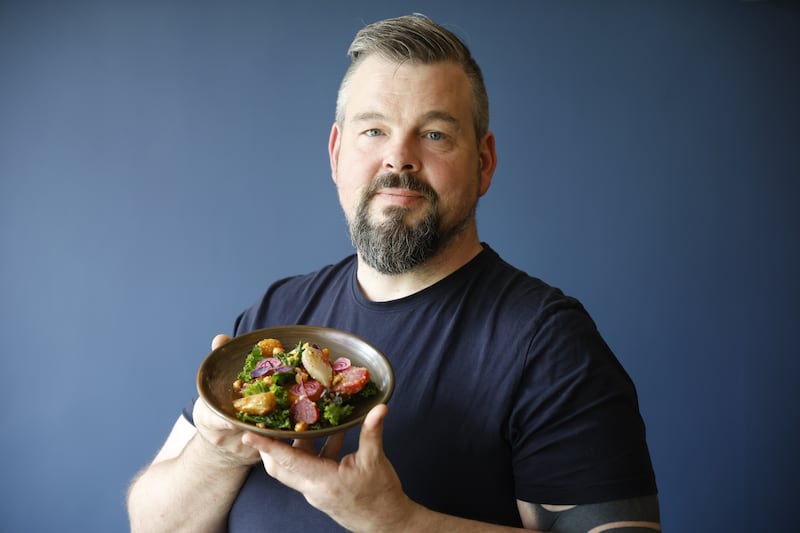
xmin=357 ymin=231 xmax=483 ymax=302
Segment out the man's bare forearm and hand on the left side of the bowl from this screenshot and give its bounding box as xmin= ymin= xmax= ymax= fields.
xmin=127 ymin=337 xmax=258 ymax=533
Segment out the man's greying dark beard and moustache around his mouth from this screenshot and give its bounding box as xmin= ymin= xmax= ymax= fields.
xmin=349 ymin=173 xmax=475 ymax=274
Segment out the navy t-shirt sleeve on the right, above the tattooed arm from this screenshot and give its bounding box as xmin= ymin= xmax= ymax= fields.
xmin=509 ymin=305 xmax=656 ymax=504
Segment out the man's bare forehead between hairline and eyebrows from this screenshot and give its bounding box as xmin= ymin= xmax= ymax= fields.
xmin=345 ymin=56 xmax=472 ymax=119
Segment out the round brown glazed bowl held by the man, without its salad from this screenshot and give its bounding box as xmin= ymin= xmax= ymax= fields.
xmin=197 ymin=325 xmax=394 ymax=439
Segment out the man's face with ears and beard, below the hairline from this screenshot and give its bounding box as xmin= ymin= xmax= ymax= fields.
xmin=329 ymin=57 xmax=494 ymax=274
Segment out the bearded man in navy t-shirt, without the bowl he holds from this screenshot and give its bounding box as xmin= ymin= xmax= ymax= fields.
xmin=128 ymin=16 xmax=660 ymax=533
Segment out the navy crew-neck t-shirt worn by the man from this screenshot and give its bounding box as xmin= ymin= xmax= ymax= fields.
xmin=186 ymin=244 xmax=656 ymax=533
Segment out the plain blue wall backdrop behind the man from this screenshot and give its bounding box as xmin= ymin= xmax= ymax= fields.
xmin=0 ymin=0 xmax=800 ymax=533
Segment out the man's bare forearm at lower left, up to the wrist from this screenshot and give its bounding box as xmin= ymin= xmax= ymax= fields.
xmin=128 ymin=434 xmax=250 ymax=533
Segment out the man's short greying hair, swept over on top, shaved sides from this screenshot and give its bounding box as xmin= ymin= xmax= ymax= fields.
xmin=336 ymin=14 xmax=489 ymax=142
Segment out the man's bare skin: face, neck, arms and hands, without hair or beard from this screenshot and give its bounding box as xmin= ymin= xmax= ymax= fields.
xmin=128 ymin=57 xmax=660 ymax=533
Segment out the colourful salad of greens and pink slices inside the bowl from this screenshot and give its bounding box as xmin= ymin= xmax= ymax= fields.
xmin=233 ymin=339 xmax=378 ymax=431
